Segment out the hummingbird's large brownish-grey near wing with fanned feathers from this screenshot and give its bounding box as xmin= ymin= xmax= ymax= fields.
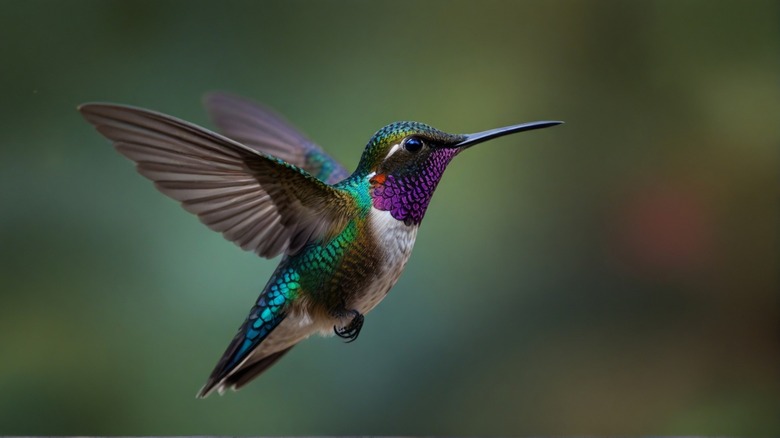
xmin=79 ymin=103 xmax=351 ymax=258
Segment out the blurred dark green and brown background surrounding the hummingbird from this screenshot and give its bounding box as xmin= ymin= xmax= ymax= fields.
xmin=0 ymin=0 xmax=780 ymax=435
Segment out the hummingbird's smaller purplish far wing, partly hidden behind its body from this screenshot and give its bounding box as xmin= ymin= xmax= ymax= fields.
xmin=204 ymin=93 xmax=349 ymax=184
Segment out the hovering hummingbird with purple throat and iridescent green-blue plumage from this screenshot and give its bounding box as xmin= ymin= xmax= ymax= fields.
xmin=78 ymin=93 xmax=563 ymax=398
